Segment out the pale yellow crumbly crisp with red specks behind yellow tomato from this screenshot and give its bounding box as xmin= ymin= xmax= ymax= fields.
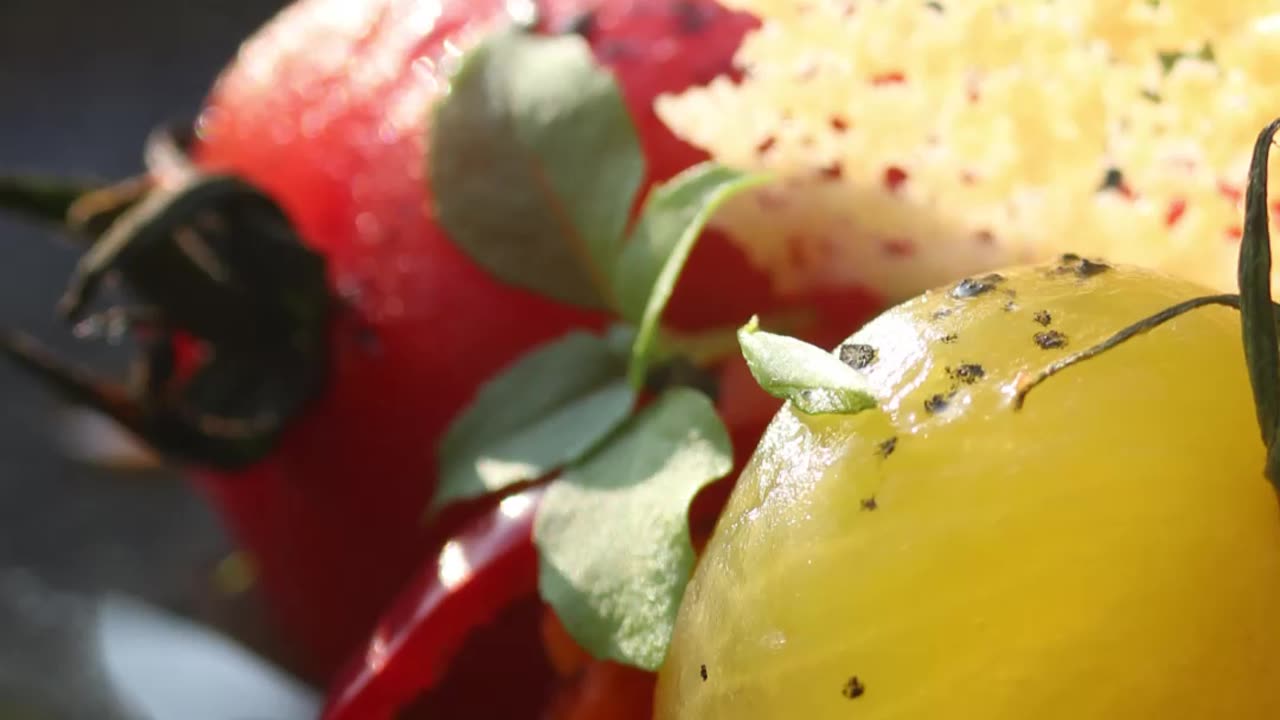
xmin=658 ymin=0 xmax=1280 ymax=297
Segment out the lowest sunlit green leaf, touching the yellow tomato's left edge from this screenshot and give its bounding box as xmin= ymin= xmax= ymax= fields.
xmin=534 ymin=389 xmax=733 ymax=670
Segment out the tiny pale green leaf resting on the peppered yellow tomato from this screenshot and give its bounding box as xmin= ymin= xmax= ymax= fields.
xmin=737 ymin=318 xmax=876 ymax=415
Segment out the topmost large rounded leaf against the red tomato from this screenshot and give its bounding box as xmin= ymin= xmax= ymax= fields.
xmin=428 ymin=29 xmax=644 ymax=309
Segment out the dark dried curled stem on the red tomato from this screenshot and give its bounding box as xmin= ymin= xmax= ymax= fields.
xmin=0 ymin=120 xmax=337 ymax=469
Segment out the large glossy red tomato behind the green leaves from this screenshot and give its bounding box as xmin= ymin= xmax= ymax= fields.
xmin=185 ymin=0 xmax=849 ymax=679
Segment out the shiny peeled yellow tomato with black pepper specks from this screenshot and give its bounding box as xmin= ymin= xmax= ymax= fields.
xmin=657 ymin=256 xmax=1280 ymax=720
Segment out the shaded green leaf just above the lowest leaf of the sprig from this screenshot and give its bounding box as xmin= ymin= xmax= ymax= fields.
xmin=431 ymin=332 xmax=635 ymax=510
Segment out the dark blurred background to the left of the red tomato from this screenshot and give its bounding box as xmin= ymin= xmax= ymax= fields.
xmin=0 ymin=0 xmax=293 ymax=720
